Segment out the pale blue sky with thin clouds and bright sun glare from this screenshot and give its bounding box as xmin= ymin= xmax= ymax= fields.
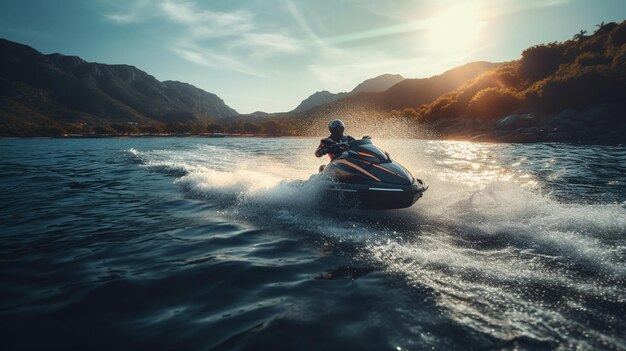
xmin=0 ymin=0 xmax=626 ymax=113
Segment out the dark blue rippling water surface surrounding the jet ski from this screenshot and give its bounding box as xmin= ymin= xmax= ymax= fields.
xmin=0 ymin=138 xmax=626 ymax=350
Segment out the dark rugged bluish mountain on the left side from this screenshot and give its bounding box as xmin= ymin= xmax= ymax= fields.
xmin=0 ymin=39 xmax=237 ymax=129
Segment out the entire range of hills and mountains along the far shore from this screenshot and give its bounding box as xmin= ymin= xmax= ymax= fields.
xmin=0 ymin=21 xmax=626 ymax=144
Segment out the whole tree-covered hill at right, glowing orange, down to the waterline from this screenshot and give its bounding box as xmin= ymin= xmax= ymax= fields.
xmin=410 ymin=21 xmax=626 ymax=144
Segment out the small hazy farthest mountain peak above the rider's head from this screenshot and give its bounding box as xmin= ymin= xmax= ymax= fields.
xmin=292 ymin=74 xmax=404 ymax=112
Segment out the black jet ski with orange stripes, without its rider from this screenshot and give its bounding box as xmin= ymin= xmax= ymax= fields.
xmin=319 ymin=137 xmax=428 ymax=209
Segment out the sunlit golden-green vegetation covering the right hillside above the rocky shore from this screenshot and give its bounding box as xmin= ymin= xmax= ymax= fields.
xmin=394 ymin=21 xmax=626 ymax=125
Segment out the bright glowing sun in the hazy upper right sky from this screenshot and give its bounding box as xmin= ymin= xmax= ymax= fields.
xmin=426 ymin=3 xmax=485 ymax=52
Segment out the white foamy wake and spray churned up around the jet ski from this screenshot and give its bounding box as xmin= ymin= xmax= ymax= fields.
xmin=129 ymin=143 xmax=626 ymax=348
